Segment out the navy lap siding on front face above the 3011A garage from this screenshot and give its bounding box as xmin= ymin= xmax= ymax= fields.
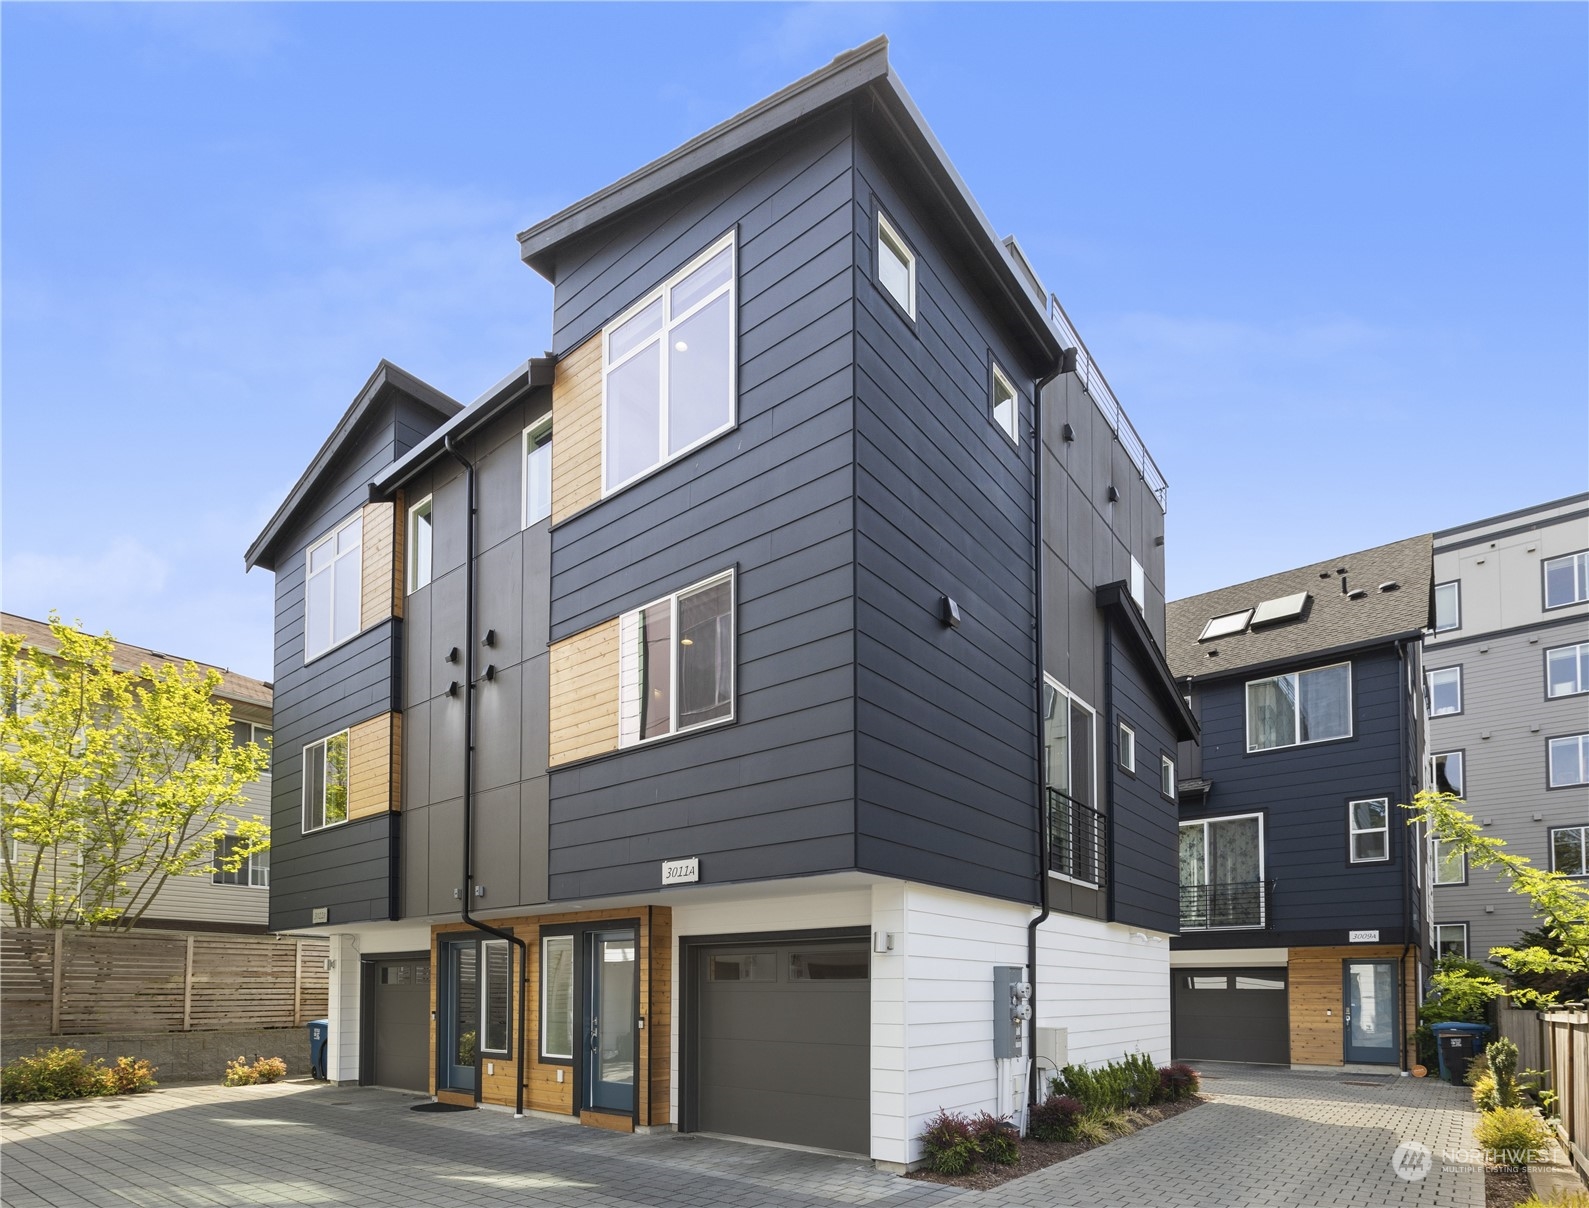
xmin=542 ymin=113 xmax=855 ymax=900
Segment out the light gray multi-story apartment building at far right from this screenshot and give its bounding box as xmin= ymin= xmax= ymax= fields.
xmin=1424 ymin=494 xmax=1589 ymax=960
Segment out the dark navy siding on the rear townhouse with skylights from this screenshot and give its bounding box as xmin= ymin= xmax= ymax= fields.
xmin=1176 ymin=650 xmax=1416 ymax=947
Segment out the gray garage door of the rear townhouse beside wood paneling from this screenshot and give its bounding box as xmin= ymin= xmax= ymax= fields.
xmin=1171 ymin=968 xmax=1290 ymax=1065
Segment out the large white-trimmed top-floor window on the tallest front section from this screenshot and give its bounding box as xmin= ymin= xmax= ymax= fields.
xmin=602 ymin=232 xmax=736 ymax=494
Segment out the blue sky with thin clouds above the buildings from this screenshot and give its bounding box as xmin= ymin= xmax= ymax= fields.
xmin=0 ymin=3 xmax=1589 ymax=679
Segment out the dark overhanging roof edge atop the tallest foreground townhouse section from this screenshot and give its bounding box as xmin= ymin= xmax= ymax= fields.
xmin=518 ymin=37 xmax=1061 ymax=362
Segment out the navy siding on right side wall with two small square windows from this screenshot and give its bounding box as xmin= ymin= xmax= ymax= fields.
xmin=853 ymin=131 xmax=1041 ymax=901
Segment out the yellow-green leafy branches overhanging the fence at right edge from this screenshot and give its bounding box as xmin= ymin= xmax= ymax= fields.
xmin=1401 ymin=788 xmax=1589 ymax=1006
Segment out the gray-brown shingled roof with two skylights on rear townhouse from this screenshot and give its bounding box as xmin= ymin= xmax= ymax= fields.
xmin=1166 ymin=532 xmax=1435 ymax=679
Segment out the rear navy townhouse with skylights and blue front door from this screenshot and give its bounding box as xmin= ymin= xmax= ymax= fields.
xmin=1170 ymin=536 xmax=1432 ymax=1068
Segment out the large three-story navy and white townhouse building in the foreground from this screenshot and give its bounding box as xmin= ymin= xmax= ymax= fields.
xmin=246 ymin=40 xmax=1195 ymax=1163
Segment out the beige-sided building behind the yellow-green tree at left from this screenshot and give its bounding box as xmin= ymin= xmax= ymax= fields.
xmin=0 ymin=612 xmax=272 ymax=933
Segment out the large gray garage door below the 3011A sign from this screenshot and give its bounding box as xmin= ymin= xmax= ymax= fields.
xmin=694 ymin=939 xmax=871 ymax=1154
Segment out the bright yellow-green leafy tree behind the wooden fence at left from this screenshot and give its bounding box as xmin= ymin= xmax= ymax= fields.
xmin=0 ymin=614 xmax=270 ymax=930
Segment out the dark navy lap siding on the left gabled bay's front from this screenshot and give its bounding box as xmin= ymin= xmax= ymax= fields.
xmin=270 ymin=391 xmax=434 ymax=930
